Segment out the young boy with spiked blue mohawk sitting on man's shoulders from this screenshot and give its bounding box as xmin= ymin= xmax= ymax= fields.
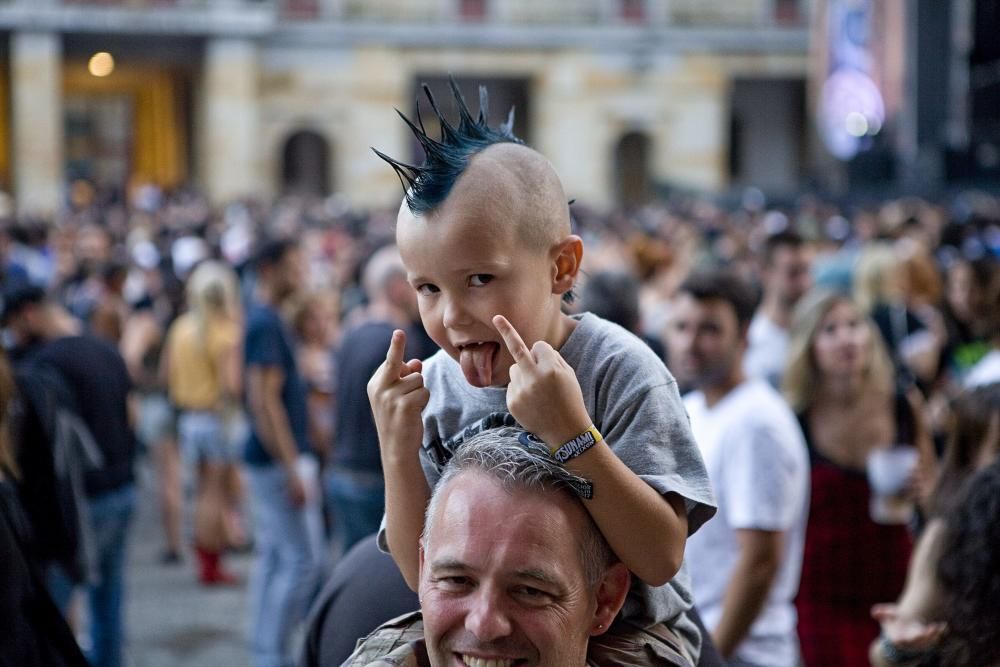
xmin=368 ymin=81 xmax=715 ymax=665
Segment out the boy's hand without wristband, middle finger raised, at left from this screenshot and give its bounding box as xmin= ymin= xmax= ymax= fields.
xmin=368 ymin=329 xmax=431 ymax=462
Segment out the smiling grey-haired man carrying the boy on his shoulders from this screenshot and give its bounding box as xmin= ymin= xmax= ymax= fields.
xmin=345 ymin=428 xmax=656 ymax=667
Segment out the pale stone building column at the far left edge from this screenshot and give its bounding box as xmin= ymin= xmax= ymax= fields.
xmin=10 ymin=32 xmax=63 ymax=216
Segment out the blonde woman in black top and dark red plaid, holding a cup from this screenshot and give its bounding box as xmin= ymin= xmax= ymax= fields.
xmin=784 ymin=290 xmax=932 ymax=667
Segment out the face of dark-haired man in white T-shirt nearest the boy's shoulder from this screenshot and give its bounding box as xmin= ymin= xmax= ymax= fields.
xmin=666 ymin=292 xmax=745 ymax=388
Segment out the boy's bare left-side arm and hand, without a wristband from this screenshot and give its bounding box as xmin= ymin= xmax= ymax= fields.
xmin=368 ymin=329 xmax=430 ymax=590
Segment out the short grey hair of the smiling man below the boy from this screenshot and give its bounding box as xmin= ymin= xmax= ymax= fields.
xmin=421 ymin=427 xmax=618 ymax=586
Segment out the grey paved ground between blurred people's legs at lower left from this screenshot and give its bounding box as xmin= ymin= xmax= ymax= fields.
xmin=125 ymin=462 xmax=251 ymax=667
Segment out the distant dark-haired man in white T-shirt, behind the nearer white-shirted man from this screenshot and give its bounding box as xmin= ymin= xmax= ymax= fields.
xmin=743 ymin=231 xmax=812 ymax=388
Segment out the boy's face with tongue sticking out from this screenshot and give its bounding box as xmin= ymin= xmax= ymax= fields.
xmin=396 ymin=196 xmax=575 ymax=387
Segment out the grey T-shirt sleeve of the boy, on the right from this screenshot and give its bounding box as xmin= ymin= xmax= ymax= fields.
xmin=600 ymin=380 xmax=715 ymax=535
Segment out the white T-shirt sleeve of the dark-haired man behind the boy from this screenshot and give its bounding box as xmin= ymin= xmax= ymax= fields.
xmin=720 ymin=423 xmax=807 ymax=531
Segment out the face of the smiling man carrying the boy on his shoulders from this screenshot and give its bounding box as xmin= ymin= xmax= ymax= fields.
xmin=420 ymin=472 xmax=598 ymax=667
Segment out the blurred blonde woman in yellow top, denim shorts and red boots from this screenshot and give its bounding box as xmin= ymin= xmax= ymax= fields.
xmin=164 ymin=261 xmax=242 ymax=585
